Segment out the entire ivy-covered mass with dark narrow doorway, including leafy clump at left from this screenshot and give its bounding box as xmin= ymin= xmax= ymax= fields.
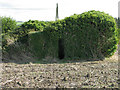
xmin=1 ymin=10 xmax=118 ymax=59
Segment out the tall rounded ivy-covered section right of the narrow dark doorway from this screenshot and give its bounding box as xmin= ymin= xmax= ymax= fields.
xmin=64 ymin=10 xmax=118 ymax=59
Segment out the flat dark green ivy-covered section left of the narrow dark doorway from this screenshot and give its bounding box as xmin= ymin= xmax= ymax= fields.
xmin=29 ymin=31 xmax=58 ymax=59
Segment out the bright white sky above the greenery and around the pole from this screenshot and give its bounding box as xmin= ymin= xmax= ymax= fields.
xmin=0 ymin=0 xmax=120 ymax=21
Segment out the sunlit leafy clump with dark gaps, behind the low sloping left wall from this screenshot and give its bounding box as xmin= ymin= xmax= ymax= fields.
xmin=15 ymin=20 xmax=51 ymax=37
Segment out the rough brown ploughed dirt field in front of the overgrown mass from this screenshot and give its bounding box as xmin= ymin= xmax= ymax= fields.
xmin=0 ymin=50 xmax=120 ymax=88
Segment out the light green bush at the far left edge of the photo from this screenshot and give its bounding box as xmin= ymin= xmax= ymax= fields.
xmin=0 ymin=17 xmax=17 ymax=51
